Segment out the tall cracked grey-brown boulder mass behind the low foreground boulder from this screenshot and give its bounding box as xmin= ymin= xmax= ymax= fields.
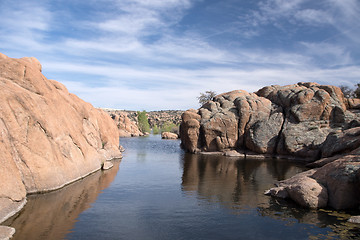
xmin=181 ymin=83 xmax=360 ymax=161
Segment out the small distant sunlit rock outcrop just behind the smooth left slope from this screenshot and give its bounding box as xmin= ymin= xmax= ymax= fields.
xmin=104 ymin=109 xmax=144 ymax=137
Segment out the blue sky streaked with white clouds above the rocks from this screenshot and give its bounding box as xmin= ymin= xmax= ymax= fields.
xmin=0 ymin=0 xmax=360 ymax=111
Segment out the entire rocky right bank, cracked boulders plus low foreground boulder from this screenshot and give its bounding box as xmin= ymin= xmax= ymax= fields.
xmin=180 ymin=83 xmax=360 ymax=209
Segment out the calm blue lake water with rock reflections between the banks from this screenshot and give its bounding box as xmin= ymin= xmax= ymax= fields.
xmin=5 ymin=135 xmax=360 ymax=240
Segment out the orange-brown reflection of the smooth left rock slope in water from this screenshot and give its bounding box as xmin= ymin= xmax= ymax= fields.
xmin=3 ymin=162 xmax=120 ymax=240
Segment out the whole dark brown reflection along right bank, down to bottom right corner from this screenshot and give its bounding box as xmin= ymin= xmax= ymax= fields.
xmin=182 ymin=154 xmax=360 ymax=239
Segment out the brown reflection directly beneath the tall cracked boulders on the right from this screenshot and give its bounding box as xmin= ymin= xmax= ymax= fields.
xmin=182 ymin=154 xmax=302 ymax=208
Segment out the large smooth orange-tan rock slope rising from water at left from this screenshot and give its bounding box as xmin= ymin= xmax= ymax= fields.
xmin=0 ymin=54 xmax=121 ymax=222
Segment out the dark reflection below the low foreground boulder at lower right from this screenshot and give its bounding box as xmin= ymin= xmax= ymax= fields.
xmin=257 ymin=198 xmax=360 ymax=239
